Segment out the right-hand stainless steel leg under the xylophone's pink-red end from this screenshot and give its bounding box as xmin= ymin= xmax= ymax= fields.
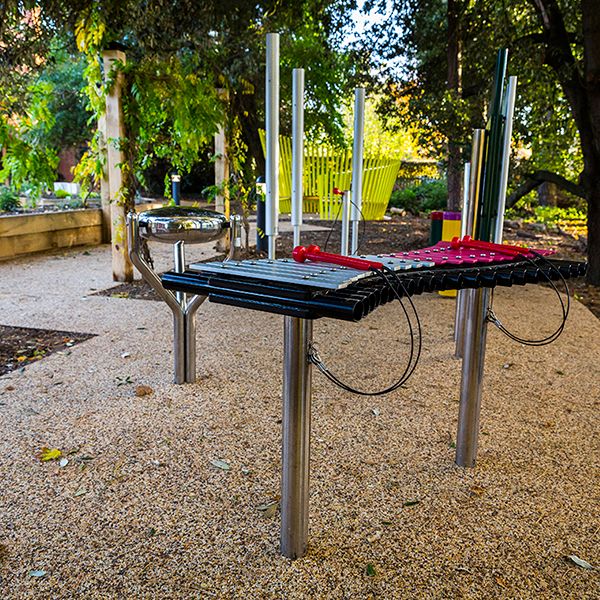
xmin=456 ymin=288 xmax=490 ymax=467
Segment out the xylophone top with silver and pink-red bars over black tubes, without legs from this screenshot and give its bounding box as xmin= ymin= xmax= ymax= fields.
xmin=162 ymin=242 xmax=586 ymax=321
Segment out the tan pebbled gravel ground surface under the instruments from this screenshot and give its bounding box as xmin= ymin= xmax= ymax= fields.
xmin=0 ymin=237 xmax=600 ymax=599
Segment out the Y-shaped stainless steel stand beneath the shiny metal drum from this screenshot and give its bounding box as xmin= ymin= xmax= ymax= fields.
xmin=127 ymin=213 xmax=206 ymax=383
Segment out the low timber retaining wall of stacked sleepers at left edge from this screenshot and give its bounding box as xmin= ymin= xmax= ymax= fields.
xmin=0 ymin=208 xmax=102 ymax=260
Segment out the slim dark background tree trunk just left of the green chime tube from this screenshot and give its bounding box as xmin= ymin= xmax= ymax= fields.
xmin=447 ymin=0 xmax=463 ymax=211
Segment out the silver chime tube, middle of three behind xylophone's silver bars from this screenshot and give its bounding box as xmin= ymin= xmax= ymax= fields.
xmin=292 ymin=69 xmax=304 ymax=247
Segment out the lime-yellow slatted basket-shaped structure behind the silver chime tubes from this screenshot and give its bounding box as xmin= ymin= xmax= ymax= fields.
xmin=259 ymin=130 xmax=401 ymax=221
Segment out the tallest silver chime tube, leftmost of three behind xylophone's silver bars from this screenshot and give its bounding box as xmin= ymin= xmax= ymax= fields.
xmin=265 ymin=33 xmax=279 ymax=259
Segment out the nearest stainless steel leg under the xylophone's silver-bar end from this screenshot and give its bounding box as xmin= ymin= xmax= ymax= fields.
xmin=280 ymin=317 xmax=312 ymax=559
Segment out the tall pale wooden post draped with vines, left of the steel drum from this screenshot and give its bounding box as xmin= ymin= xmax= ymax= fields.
xmin=102 ymin=50 xmax=133 ymax=281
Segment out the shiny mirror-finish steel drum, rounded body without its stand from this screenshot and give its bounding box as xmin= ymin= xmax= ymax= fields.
xmin=138 ymin=206 xmax=229 ymax=244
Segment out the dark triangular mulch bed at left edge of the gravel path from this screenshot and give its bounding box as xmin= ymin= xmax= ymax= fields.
xmin=0 ymin=325 xmax=94 ymax=375
